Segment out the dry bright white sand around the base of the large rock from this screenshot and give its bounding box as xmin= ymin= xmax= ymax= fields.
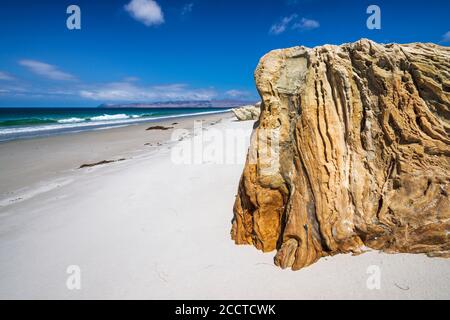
xmin=0 ymin=116 xmax=450 ymax=299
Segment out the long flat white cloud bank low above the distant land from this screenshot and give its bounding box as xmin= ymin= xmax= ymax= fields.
xmin=79 ymin=82 xmax=217 ymax=102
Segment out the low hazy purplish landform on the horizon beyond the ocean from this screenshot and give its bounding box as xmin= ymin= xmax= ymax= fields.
xmin=98 ymin=100 xmax=257 ymax=108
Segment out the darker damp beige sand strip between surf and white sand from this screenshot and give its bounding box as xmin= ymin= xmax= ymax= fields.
xmin=0 ymin=112 xmax=232 ymax=206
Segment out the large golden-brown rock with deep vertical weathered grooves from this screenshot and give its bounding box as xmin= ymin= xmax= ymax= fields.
xmin=232 ymin=39 xmax=450 ymax=270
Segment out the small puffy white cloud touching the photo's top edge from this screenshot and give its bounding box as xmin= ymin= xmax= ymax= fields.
xmin=125 ymin=0 xmax=164 ymax=26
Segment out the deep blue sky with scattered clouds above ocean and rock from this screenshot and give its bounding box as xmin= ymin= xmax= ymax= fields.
xmin=0 ymin=0 xmax=450 ymax=107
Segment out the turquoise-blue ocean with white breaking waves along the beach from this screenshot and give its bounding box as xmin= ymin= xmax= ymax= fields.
xmin=0 ymin=108 xmax=230 ymax=141
